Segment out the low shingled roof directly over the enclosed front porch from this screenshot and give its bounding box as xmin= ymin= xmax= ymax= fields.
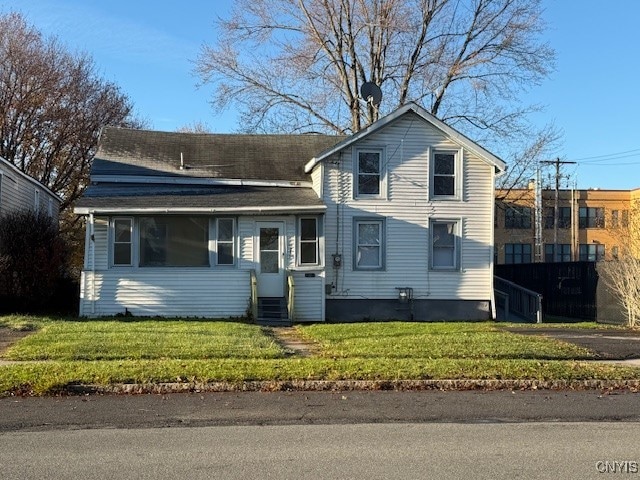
xmin=76 ymin=184 xmax=323 ymax=210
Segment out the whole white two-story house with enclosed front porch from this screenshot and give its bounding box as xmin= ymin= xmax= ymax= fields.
xmin=75 ymin=104 xmax=505 ymax=322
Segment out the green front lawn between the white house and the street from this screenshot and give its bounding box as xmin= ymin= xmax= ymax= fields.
xmin=0 ymin=317 xmax=640 ymax=395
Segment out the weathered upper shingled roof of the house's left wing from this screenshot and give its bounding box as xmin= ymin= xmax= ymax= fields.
xmin=91 ymin=127 xmax=344 ymax=181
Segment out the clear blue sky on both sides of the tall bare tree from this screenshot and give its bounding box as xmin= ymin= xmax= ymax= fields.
xmin=0 ymin=0 xmax=640 ymax=189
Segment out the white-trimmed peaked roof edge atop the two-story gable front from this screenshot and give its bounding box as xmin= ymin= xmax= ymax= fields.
xmin=304 ymin=102 xmax=507 ymax=173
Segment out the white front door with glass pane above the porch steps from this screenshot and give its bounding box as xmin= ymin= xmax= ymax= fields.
xmin=256 ymin=222 xmax=285 ymax=297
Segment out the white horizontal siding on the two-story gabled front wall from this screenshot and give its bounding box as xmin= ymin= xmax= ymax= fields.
xmin=324 ymin=114 xmax=494 ymax=300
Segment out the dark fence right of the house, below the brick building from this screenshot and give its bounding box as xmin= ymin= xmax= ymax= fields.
xmin=494 ymin=262 xmax=598 ymax=320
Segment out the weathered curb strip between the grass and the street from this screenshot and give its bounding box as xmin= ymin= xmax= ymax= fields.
xmin=66 ymin=380 xmax=640 ymax=395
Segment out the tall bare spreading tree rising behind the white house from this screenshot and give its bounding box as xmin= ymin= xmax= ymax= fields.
xmin=196 ymin=0 xmax=555 ymax=182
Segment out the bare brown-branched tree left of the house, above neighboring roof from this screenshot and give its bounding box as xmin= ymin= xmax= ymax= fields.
xmin=0 ymin=13 xmax=141 ymax=211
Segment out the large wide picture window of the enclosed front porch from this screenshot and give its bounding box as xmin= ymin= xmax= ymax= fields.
xmin=140 ymin=216 xmax=209 ymax=267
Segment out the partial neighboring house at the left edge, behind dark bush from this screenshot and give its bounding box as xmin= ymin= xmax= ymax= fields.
xmin=0 ymin=157 xmax=62 ymax=223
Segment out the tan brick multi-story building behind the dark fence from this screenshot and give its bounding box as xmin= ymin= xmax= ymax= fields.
xmin=494 ymin=183 xmax=640 ymax=264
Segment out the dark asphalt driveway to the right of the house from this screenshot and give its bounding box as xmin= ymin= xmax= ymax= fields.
xmin=505 ymin=326 xmax=640 ymax=363
